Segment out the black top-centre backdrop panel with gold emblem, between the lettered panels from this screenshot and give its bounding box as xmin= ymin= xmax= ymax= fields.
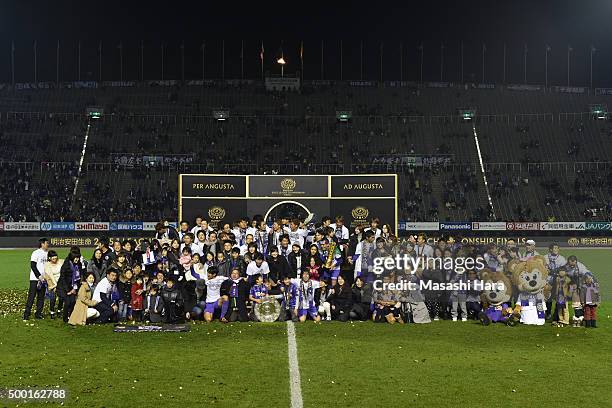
xmin=248 ymin=176 xmax=329 ymax=198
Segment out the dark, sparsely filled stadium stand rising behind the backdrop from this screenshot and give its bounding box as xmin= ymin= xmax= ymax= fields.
xmin=0 ymin=81 xmax=612 ymax=221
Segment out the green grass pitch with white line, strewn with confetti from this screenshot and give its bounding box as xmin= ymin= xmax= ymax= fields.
xmin=0 ymin=249 xmax=612 ymax=407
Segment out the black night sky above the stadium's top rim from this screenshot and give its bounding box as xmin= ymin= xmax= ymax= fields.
xmin=0 ymin=0 xmax=612 ymax=86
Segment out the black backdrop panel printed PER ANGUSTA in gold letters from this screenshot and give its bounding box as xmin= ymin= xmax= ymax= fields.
xmin=179 ymin=174 xmax=247 ymax=197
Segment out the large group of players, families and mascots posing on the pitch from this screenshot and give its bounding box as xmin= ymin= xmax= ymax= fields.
xmin=23 ymin=216 xmax=600 ymax=327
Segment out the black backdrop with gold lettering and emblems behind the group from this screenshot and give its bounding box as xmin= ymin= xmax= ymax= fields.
xmin=179 ymin=174 xmax=397 ymax=229
